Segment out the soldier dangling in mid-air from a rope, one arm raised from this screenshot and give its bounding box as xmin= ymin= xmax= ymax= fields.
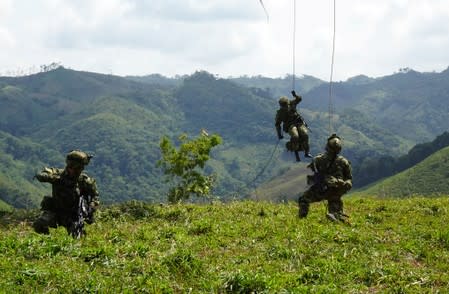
xmin=275 ymin=91 xmax=312 ymax=161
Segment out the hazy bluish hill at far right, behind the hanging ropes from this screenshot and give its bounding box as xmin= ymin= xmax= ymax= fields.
xmin=304 ymin=68 xmax=449 ymax=143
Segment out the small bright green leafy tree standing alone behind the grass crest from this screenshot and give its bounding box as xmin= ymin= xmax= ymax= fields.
xmin=157 ymin=130 xmax=222 ymax=203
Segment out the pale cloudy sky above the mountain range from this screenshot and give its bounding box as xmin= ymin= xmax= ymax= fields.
xmin=0 ymin=0 xmax=449 ymax=81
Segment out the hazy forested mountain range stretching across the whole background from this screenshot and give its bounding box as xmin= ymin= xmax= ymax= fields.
xmin=0 ymin=67 xmax=449 ymax=207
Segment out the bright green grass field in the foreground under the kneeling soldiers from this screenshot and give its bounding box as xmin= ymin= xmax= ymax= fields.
xmin=0 ymin=197 xmax=449 ymax=293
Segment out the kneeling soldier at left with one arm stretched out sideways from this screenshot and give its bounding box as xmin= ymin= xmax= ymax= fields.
xmin=33 ymin=150 xmax=99 ymax=234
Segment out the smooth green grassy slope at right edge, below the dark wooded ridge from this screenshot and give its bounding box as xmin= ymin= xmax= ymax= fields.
xmin=352 ymin=147 xmax=449 ymax=197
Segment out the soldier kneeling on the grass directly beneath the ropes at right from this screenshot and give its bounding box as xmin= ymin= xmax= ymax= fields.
xmin=298 ymin=134 xmax=352 ymax=221
